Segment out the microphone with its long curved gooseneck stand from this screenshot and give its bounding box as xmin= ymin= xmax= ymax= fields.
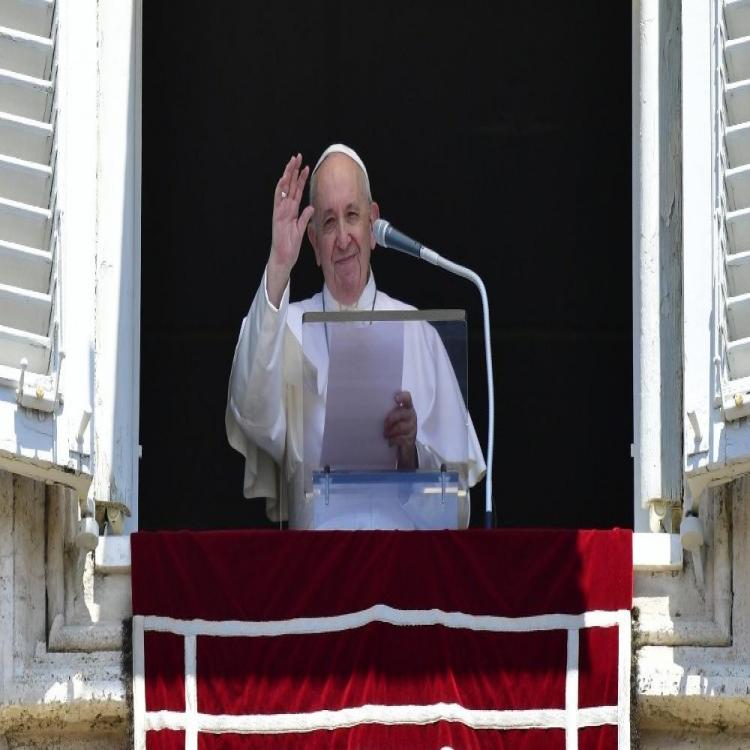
xmin=372 ymin=219 xmax=495 ymax=529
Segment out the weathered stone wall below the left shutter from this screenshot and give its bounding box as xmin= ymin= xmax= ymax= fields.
xmin=0 ymin=471 xmax=130 ymax=750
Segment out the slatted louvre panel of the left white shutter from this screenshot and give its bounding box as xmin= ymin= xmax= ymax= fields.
xmin=0 ymin=0 xmax=61 ymax=400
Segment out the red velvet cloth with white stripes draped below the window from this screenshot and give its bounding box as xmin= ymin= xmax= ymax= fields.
xmin=131 ymin=530 xmax=632 ymax=750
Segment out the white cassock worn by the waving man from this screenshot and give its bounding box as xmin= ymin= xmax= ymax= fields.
xmin=225 ymin=272 xmax=486 ymax=528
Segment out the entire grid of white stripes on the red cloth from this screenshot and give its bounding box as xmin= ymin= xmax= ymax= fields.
xmin=133 ymin=604 xmax=631 ymax=750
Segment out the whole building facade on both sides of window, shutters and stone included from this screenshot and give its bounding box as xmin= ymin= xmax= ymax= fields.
xmin=0 ymin=0 xmax=750 ymax=750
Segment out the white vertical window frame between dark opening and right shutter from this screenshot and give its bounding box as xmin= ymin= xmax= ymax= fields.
xmin=632 ymin=0 xmax=683 ymax=569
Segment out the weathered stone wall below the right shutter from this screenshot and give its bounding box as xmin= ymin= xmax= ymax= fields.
xmin=635 ymin=479 xmax=750 ymax=750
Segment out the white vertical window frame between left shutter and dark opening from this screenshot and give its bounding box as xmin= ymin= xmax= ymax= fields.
xmin=93 ymin=0 xmax=143 ymax=532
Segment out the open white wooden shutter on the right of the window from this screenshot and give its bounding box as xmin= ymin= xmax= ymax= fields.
xmin=681 ymin=0 xmax=750 ymax=499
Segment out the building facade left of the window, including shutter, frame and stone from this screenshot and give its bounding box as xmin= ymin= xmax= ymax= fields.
xmin=0 ymin=0 xmax=141 ymax=748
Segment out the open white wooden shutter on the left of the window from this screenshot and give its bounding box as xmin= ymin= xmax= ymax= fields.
xmin=0 ymin=0 xmax=96 ymax=506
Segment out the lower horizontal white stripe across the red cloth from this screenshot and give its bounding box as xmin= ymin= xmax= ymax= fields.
xmin=146 ymin=703 xmax=618 ymax=734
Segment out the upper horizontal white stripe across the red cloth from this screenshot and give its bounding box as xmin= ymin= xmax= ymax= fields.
xmin=144 ymin=604 xmax=629 ymax=637
